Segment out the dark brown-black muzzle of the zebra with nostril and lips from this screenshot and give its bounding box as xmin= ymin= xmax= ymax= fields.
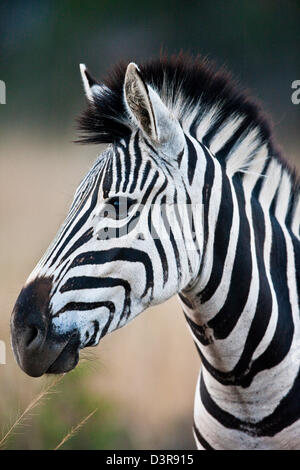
xmin=11 ymin=277 xmax=78 ymax=377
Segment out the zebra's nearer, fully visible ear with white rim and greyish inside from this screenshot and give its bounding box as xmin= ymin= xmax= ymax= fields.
xmin=124 ymin=62 xmax=182 ymax=148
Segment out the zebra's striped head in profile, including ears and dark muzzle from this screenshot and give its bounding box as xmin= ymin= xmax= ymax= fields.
xmin=11 ymin=63 xmax=199 ymax=376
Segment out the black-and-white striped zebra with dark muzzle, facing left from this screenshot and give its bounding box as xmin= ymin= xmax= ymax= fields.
xmin=11 ymin=53 xmax=300 ymax=450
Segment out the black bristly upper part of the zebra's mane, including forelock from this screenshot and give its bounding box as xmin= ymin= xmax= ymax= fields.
xmin=77 ymin=53 xmax=296 ymax=189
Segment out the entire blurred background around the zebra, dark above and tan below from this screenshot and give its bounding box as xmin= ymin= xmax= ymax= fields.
xmin=0 ymin=0 xmax=300 ymax=449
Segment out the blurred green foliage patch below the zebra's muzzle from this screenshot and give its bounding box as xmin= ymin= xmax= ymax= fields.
xmin=7 ymin=364 xmax=132 ymax=450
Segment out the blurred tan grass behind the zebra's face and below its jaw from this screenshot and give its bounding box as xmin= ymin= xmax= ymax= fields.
xmin=0 ymin=135 xmax=199 ymax=448
